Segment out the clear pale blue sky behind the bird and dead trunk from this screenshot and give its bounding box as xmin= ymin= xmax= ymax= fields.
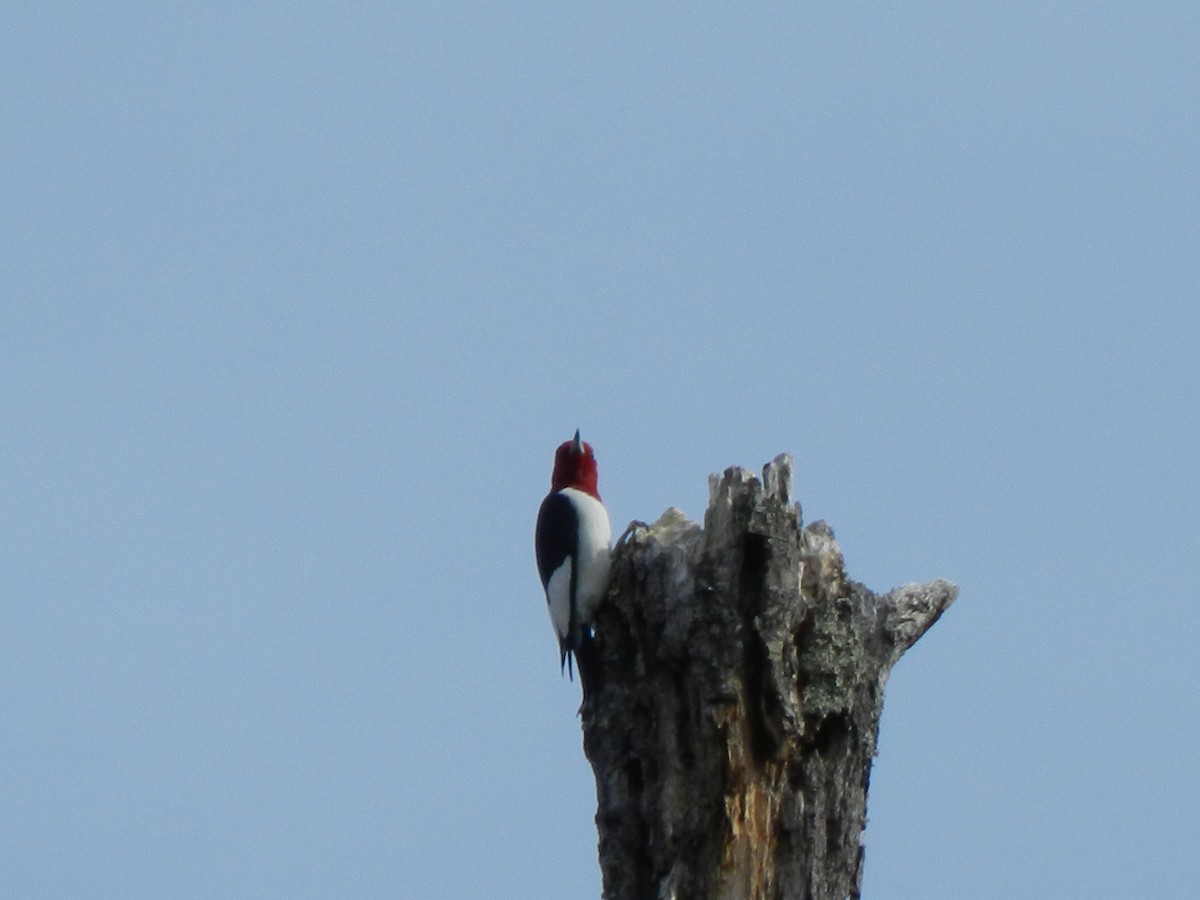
xmin=0 ymin=7 xmax=1200 ymax=900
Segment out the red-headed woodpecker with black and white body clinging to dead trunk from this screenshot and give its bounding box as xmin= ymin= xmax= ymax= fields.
xmin=534 ymin=430 xmax=612 ymax=688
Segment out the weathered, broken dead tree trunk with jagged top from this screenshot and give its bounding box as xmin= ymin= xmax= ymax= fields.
xmin=581 ymin=455 xmax=958 ymax=900
